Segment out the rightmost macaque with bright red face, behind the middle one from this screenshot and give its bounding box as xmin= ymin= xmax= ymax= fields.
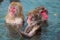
xmin=35 ymin=6 xmax=48 ymax=22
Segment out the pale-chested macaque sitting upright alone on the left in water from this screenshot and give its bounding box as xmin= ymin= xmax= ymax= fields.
xmin=5 ymin=2 xmax=24 ymax=31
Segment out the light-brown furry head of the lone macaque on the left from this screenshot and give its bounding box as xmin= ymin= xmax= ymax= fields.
xmin=8 ymin=2 xmax=22 ymax=15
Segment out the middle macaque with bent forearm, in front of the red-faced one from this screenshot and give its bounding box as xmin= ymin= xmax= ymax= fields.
xmin=20 ymin=10 xmax=41 ymax=38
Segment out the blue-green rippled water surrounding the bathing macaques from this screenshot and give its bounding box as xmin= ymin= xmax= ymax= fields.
xmin=0 ymin=0 xmax=60 ymax=40
